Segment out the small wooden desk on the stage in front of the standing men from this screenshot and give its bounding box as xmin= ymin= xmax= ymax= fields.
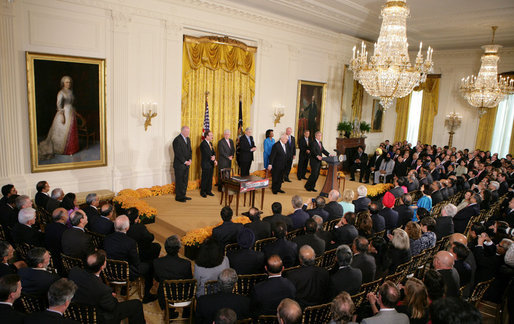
xmin=222 ymin=176 xmax=269 ymax=216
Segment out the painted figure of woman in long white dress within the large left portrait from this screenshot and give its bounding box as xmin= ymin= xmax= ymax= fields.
xmin=38 ymin=75 xmax=79 ymax=159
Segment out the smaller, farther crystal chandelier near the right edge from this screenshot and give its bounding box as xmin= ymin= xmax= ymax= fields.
xmin=459 ymin=26 xmax=514 ymax=117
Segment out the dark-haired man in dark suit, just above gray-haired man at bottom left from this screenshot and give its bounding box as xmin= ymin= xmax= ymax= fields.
xmin=18 ymin=247 xmax=59 ymax=296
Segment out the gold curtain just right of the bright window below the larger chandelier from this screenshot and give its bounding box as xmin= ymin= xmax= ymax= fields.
xmin=414 ymin=75 xmax=441 ymax=144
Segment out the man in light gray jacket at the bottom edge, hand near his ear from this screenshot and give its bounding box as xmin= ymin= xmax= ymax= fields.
xmin=361 ymin=280 xmax=409 ymax=324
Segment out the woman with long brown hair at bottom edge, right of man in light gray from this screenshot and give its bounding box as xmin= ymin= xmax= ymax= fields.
xmin=395 ymin=278 xmax=429 ymax=324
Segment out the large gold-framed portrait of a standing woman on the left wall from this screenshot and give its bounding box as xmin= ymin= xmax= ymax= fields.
xmin=25 ymin=52 xmax=107 ymax=172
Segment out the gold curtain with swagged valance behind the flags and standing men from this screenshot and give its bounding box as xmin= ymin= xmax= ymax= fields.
xmin=181 ymin=36 xmax=257 ymax=180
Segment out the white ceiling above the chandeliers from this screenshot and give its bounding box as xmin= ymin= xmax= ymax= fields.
xmin=225 ymin=0 xmax=514 ymax=50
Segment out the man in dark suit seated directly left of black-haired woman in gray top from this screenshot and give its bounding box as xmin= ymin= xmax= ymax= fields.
xmin=153 ymin=235 xmax=193 ymax=309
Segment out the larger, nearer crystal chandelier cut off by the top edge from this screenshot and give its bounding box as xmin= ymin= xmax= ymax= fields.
xmin=350 ymin=0 xmax=433 ymax=111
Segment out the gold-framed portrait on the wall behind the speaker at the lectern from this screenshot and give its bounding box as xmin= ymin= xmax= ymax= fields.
xmin=295 ymin=80 xmax=327 ymax=143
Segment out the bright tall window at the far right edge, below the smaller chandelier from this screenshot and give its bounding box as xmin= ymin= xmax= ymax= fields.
xmin=491 ymin=95 xmax=514 ymax=158
